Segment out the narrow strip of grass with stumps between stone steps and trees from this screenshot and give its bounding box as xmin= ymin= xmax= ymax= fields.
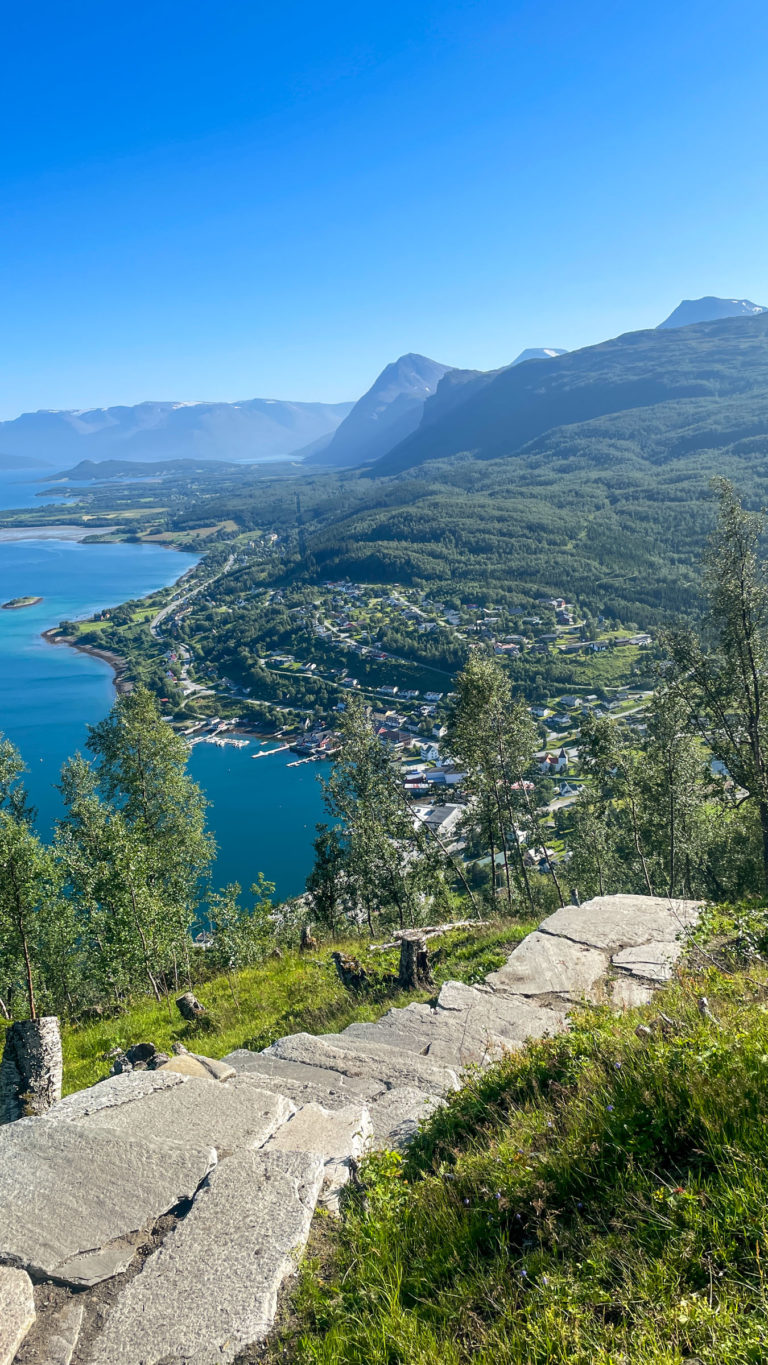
xmin=49 ymin=920 xmax=535 ymax=1095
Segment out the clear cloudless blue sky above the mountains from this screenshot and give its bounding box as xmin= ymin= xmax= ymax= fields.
xmin=0 ymin=0 xmax=768 ymax=418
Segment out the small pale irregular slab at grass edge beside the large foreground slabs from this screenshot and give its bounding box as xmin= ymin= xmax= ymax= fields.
xmin=266 ymin=1104 xmax=374 ymax=1212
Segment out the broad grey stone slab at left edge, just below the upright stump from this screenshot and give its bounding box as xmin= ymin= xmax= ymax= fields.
xmin=0 ymin=1119 xmax=216 ymax=1287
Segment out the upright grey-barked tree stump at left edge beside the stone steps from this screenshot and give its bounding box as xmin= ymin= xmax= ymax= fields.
xmin=0 ymin=1014 xmax=61 ymax=1123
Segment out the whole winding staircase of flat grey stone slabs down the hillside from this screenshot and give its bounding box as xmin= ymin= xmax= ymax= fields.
xmin=0 ymin=895 xmax=698 ymax=1365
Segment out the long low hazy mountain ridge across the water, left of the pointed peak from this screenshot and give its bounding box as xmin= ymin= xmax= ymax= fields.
xmin=0 ymin=399 xmax=352 ymax=465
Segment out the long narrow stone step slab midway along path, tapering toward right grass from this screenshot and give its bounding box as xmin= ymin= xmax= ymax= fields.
xmin=266 ymin=1033 xmax=458 ymax=1095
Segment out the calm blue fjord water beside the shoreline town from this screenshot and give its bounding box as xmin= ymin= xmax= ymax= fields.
xmin=0 ymin=474 xmax=323 ymax=895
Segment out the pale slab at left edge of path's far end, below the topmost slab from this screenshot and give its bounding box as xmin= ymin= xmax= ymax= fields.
xmin=486 ymin=921 xmax=608 ymax=1001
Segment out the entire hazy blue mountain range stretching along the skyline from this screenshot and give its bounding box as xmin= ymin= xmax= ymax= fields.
xmin=0 ymin=296 xmax=765 ymax=474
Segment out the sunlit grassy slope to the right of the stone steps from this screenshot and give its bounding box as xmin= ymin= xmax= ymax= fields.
xmin=267 ymin=969 xmax=768 ymax=1365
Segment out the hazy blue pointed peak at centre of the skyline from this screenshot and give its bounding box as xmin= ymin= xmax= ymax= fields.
xmin=306 ymin=355 xmax=450 ymax=468
